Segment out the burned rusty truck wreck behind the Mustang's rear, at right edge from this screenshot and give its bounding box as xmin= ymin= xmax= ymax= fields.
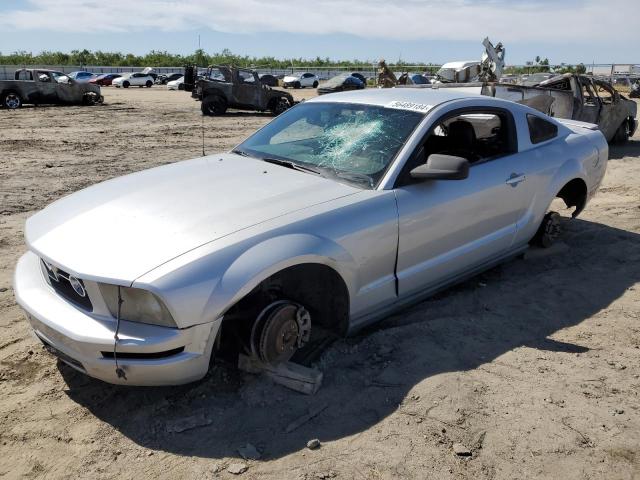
xmin=482 ymin=73 xmax=638 ymax=143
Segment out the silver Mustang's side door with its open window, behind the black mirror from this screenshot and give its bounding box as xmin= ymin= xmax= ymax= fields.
xmin=395 ymin=109 xmax=527 ymax=297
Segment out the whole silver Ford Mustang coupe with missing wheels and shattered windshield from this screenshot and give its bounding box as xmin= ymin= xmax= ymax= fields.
xmin=15 ymin=89 xmax=608 ymax=385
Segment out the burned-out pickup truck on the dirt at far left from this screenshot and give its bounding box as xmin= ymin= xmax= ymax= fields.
xmin=0 ymin=69 xmax=103 ymax=110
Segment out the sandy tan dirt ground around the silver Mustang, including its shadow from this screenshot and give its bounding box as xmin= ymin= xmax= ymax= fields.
xmin=0 ymin=87 xmax=640 ymax=480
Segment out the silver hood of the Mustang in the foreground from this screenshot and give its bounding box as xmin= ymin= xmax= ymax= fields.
xmin=25 ymin=154 xmax=360 ymax=285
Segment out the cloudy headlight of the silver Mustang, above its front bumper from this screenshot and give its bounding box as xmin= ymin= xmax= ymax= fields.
xmin=100 ymin=283 xmax=177 ymax=328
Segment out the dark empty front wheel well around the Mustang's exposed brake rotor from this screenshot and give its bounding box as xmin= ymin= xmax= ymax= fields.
xmin=216 ymin=263 xmax=350 ymax=358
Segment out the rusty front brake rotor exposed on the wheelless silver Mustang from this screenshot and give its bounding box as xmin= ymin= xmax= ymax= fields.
xmin=252 ymin=301 xmax=311 ymax=365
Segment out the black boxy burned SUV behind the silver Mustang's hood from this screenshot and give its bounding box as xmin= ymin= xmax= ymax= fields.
xmin=191 ymin=66 xmax=294 ymax=115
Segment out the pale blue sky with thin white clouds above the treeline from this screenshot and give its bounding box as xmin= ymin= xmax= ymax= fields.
xmin=0 ymin=0 xmax=640 ymax=65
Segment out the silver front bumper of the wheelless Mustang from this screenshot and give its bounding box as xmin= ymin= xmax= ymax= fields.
xmin=14 ymin=252 xmax=222 ymax=385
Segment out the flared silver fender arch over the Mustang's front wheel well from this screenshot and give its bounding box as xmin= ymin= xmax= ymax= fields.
xmin=203 ymin=234 xmax=358 ymax=318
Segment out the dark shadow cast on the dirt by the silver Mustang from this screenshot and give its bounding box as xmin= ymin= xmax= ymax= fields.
xmin=59 ymin=219 xmax=640 ymax=460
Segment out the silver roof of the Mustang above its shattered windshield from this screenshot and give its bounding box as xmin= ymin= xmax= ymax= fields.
xmin=307 ymin=88 xmax=482 ymax=107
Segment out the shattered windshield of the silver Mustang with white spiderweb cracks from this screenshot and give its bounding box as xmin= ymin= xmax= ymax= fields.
xmin=234 ymin=102 xmax=424 ymax=188
